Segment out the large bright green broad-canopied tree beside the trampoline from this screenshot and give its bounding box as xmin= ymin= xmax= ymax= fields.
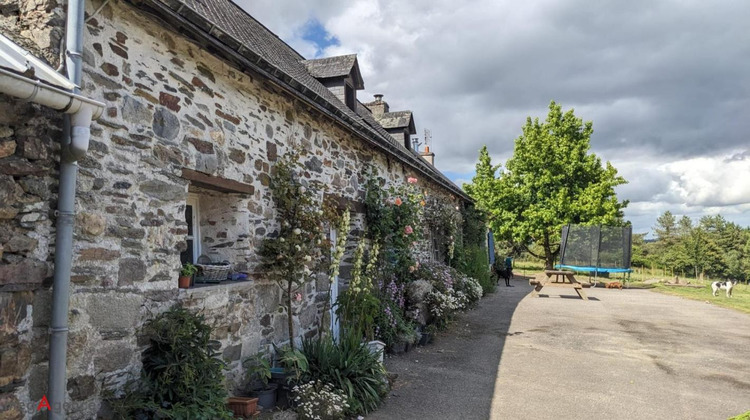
xmin=464 ymin=101 xmax=628 ymax=269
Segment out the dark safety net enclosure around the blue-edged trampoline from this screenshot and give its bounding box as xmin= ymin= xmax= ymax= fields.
xmin=560 ymin=225 xmax=633 ymax=272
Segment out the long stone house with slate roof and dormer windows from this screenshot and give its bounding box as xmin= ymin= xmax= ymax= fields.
xmin=0 ymin=0 xmax=469 ymax=418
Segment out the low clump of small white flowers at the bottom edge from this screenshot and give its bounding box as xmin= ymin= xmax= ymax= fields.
xmin=292 ymin=380 xmax=349 ymax=420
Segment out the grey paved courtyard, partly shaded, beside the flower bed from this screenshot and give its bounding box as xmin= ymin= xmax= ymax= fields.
xmin=368 ymin=281 xmax=750 ymax=420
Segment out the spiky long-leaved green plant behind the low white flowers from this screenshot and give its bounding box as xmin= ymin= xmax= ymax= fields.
xmin=302 ymin=330 xmax=388 ymax=416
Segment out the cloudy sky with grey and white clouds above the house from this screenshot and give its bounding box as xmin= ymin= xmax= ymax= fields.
xmin=241 ymin=0 xmax=750 ymax=236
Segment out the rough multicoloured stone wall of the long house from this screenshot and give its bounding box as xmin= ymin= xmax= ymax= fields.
xmin=0 ymin=0 xmax=464 ymax=418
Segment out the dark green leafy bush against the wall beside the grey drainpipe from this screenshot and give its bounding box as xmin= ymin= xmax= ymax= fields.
xmin=110 ymin=306 xmax=232 ymax=419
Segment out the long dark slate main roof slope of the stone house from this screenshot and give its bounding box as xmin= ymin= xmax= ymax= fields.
xmin=129 ymin=0 xmax=471 ymax=201
